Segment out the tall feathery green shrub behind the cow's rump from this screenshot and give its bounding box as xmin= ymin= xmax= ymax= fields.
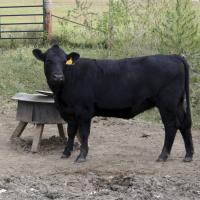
xmin=157 ymin=0 xmax=200 ymax=56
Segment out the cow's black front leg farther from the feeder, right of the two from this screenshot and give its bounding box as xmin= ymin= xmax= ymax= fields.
xmin=75 ymin=121 xmax=91 ymax=163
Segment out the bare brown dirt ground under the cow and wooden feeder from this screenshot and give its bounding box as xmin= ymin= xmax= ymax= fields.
xmin=0 ymin=105 xmax=200 ymax=200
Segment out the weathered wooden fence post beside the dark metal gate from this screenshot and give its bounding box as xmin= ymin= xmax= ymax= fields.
xmin=43 ymin=0 xmax=52 ymax=41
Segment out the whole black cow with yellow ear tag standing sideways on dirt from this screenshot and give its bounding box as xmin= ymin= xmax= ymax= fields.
xmin=33 ymin=45 xmax=193 ymax=162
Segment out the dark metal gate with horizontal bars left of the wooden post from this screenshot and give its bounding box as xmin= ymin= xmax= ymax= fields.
xmin=0 ymin=0 xmax=45 ymax=39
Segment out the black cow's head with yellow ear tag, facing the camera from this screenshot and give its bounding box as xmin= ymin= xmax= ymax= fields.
xmin=33 ymin=44 xmax=80 ymax=88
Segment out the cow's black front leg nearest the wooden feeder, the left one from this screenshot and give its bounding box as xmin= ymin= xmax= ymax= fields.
xmin=61 ymin=121 xmax=78 ymax=158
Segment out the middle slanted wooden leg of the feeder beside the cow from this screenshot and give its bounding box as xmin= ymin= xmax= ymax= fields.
xmin=31 ymin=124 xmax=44 ymax=153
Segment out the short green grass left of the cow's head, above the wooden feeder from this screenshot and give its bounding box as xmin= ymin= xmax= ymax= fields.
xmin=0 ymin=48 xmax=47 ymax=104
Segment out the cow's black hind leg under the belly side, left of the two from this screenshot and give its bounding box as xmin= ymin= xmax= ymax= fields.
xmin=157 ymin=109 xmax=177 ymax=161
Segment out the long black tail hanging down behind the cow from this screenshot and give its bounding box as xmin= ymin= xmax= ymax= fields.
xmin=181 ymin=56 xmax=192 ymax=129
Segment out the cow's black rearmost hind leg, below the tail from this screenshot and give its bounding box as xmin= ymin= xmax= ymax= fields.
xmin=178 ymin=104 xmax=194 ymax=162
